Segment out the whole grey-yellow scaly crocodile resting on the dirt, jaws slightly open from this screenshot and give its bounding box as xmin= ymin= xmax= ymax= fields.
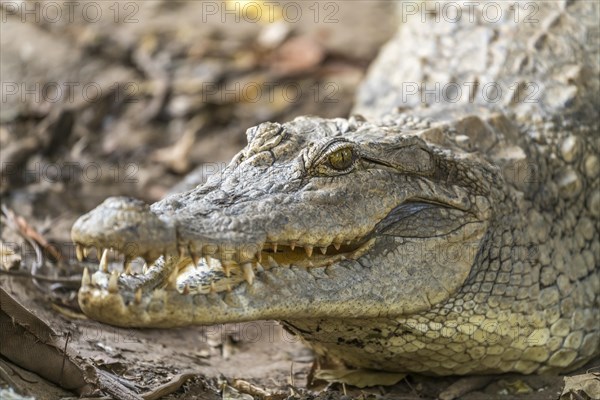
xmin=72 ymin=1 xmax=600 ymax=375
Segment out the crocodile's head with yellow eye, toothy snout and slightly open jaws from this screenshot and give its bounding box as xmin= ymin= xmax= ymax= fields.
xmin=72 ymin=113 xmax=498 ymax=327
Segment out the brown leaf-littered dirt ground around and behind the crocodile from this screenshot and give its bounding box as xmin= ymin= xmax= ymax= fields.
xmin=0 ymin=0 xmax=600 ymax=400
